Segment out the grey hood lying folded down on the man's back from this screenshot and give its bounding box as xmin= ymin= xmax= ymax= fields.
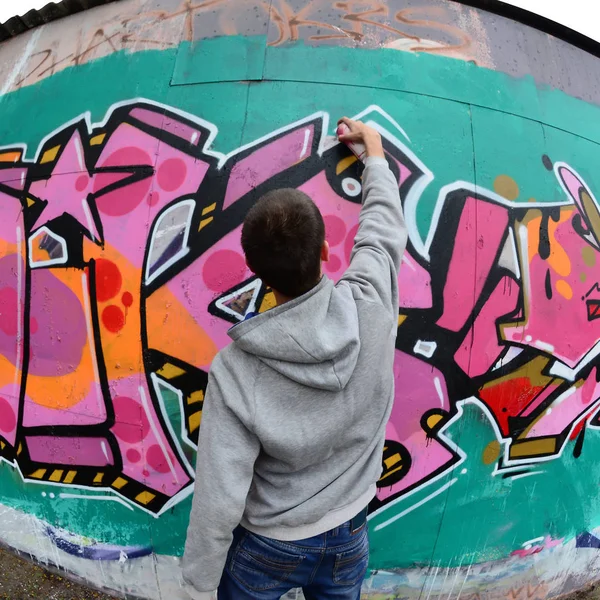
xmin=229 ymin=276 xmax=360 ymax=391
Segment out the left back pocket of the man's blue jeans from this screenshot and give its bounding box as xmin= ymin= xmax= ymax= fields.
xmin=230 ymin=532 xmax=305 ymax=592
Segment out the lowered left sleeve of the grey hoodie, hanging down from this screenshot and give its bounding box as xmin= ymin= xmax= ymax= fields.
xmin=182 ymin=353 xmax=260 ymax=592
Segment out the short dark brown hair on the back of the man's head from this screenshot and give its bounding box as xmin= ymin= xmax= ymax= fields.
xmin=242 ymin=188 xmax=325 ymax=298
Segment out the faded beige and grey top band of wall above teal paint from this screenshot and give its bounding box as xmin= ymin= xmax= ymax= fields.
xmin=0 ymin=0 xmax=600 ymax=110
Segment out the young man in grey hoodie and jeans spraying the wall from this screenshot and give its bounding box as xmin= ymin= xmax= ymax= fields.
xmin=183 ymin=118 xmax=407 ymax=600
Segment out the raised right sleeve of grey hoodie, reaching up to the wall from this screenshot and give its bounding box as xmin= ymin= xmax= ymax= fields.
xmin=341 ymin=157 xmax=407 ymax=314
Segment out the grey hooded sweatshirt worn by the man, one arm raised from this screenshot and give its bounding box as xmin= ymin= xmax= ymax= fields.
xmin=183 ymin=158 xmax=407 ymax=591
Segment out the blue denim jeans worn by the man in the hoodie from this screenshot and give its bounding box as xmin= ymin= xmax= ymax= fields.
xmin=218 ymin=510 xmax=369 ymax=600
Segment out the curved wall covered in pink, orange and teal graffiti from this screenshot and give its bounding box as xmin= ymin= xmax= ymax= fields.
xmin=0 ymin=0 xmax=600 ymax=600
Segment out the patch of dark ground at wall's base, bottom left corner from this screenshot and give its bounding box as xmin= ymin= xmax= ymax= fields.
xmin=0 ymin=548 xmax=115 ymax=600
